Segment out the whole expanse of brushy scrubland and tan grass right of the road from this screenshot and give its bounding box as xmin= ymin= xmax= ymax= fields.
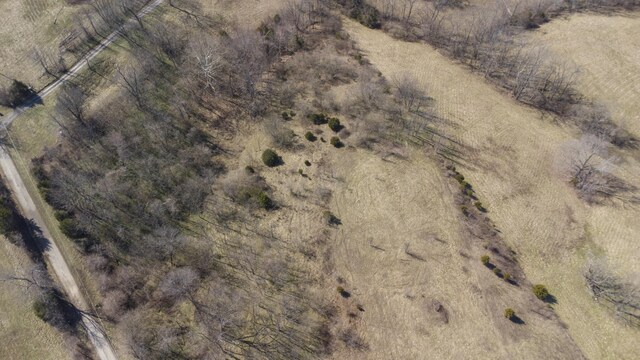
xmin=1 ymin=0 xmax=640 ymax=359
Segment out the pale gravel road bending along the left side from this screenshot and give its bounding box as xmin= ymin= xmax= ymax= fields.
xmin=0 ymin=0 xmax=164 ymax=360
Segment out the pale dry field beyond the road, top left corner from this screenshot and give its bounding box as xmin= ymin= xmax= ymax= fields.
xmin=0 ymin=0 xmax=80 ymax=89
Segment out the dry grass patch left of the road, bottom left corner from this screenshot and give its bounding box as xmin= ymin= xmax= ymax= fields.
xmin=0 ymin=237 xmax=69 ymax=360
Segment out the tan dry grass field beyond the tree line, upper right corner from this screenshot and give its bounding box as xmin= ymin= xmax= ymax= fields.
xmin=531 ymin=13 xmax=640 ymax=137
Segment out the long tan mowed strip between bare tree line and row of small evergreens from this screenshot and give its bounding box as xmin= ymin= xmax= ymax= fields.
xmin=346 ymin=21 xmax=640 ymax=359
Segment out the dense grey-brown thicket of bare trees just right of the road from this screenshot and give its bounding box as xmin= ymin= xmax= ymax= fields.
xmin=34 ymin=1 xmax=344 ymax=359
